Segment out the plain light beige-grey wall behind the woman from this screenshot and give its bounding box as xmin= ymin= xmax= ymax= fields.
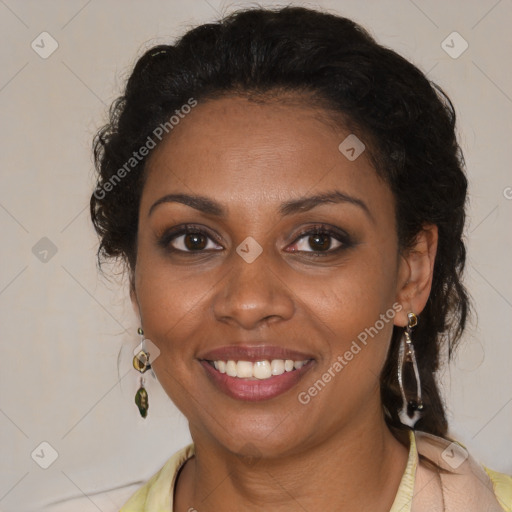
xmin=0 ymin=0 xmax=512 ymax=512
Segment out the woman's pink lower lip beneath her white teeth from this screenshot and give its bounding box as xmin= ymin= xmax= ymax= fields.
xmin=200 ymin=360 xmax=313 ymax=402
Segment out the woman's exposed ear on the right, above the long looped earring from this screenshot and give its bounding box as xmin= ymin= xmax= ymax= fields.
xmin=394 ymin=224 xmax=438 ymax=327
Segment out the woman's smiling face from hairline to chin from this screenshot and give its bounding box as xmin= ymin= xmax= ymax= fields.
xmin=132 ymin=97 xmax=405 ymax=456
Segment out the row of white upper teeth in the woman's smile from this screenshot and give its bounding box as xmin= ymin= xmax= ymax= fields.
xmin=208 ymin=359 xmax=308 ymax=380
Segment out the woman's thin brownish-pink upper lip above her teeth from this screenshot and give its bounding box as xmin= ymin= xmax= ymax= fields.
xmin=198 ymin=344 xmax=314 ymax=363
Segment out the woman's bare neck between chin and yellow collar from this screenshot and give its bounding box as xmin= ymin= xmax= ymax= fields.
xmin=174 ymin=417 xmax=408 ymax=512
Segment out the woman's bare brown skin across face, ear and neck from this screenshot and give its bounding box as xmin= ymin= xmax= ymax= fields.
xmin=131 ymin=97 xmax=437 ymax=512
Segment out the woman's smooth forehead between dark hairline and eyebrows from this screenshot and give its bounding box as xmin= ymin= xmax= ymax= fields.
xmin=141 ymin=97 xmax=390 ymax=218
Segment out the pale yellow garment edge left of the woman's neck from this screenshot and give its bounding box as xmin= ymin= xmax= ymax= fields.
xmin=119 ymin=444 xmax=194 ymax=512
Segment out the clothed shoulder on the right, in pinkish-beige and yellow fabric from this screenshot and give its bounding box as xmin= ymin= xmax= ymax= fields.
xmin=415 ymin=432 xmax=512 ymax=512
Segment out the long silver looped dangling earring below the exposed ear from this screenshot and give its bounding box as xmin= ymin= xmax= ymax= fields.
xmin=398 ymin=313 xmax=424 ymax=428
